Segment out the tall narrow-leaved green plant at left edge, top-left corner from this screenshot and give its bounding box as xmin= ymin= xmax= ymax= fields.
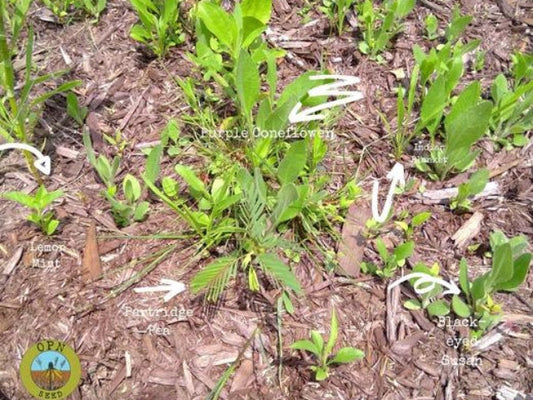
xmin=0 ymin=1 xmax=81 ymax=179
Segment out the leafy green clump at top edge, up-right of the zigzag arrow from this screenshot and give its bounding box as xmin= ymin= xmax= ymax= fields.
xmin=357 ymin=0 xmax=415 ymax=60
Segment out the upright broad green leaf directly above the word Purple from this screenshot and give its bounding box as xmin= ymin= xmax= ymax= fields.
xmin=235 ymin=49 xmax=261 ymax=117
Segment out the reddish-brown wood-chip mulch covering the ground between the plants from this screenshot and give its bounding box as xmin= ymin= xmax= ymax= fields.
xmin=0 ymin=0 xmax=533 ymax=400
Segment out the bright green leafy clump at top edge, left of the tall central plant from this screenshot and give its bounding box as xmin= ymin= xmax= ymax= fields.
xmin=130 ymin=0 xmax=185 ymax=57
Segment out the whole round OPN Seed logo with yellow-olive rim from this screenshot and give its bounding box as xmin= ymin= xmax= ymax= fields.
xmin=20 ymin=339 xmax=81 ymax=400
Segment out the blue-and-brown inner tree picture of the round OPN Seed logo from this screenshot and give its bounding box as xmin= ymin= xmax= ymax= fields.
xmin=31 ymin=351 xmax=70 ymax=390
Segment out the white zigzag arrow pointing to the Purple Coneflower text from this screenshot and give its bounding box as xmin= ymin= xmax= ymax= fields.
xmin=289 ymin=75 xmax=363 ymax=124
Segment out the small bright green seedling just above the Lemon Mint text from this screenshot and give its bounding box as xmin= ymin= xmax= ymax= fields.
xmin=2 ymin=185 xmax=63 ymax=236
